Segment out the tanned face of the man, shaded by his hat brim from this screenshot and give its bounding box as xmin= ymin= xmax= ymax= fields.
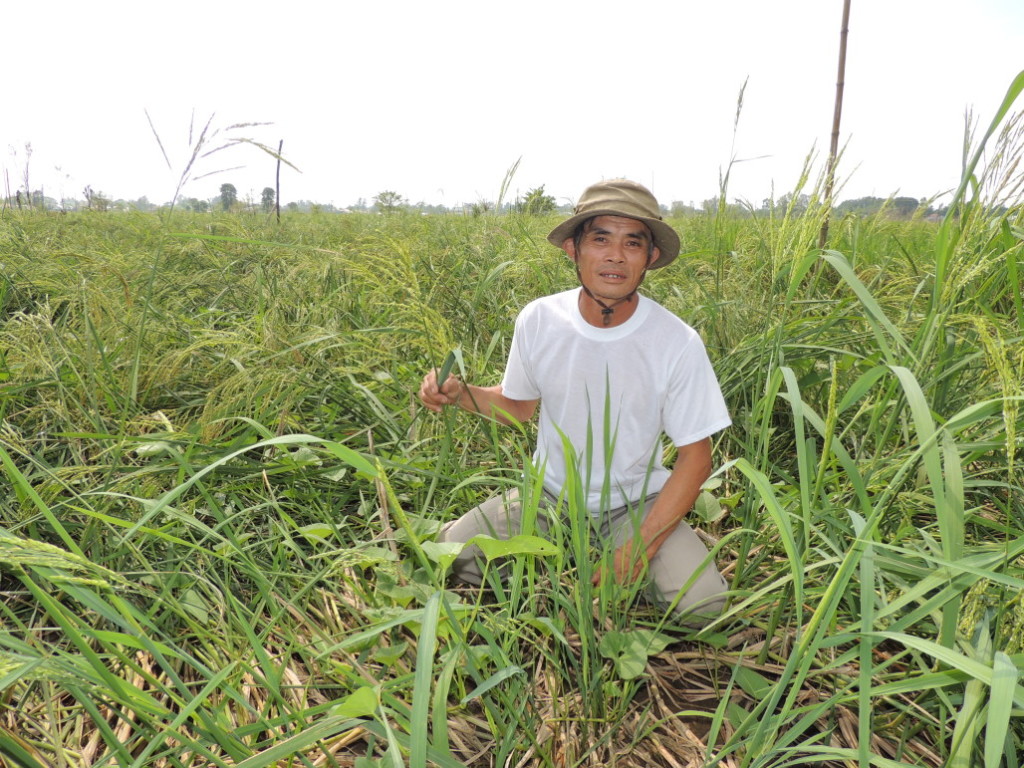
xmin=562 ymin=216 xmax=659 ymax=301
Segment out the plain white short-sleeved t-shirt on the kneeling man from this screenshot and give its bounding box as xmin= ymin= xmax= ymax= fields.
xmin=502 ymin=288 xmax=731 ymax=513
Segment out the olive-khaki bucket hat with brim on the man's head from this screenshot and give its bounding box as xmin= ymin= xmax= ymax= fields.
xmin=548 ymin=178 xmax=679 ymax=269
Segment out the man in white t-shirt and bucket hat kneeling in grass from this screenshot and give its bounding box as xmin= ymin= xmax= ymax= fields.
xmin=420 ymin=179 xmax=730 ymax=622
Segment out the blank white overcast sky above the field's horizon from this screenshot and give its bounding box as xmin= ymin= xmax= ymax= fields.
xmin=0 ymin=0 xmax=1024 ymax=207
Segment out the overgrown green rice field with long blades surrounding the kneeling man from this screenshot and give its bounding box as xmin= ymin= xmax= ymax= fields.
xmin=0 ymin=85 xmax=1024 ymax=768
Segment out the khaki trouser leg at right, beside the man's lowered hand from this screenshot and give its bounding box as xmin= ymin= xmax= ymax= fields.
xmin=610 ymin=495 xmax=729 ymax=626
